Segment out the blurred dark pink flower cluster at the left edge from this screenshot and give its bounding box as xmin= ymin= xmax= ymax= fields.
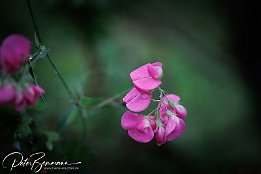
xmin=0 ymin=35 xmax=44 ymax=111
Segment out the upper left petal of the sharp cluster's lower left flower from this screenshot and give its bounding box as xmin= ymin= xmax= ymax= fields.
xmin=121 ymin=111 xmax=144 ymax=130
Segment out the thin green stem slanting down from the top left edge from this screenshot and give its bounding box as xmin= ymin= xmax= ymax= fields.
xmin=26 ymin=0 xmax=74 ymax=101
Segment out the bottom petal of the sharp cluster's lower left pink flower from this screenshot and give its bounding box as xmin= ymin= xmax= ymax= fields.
xmin=128 ymin=126 xmax=154 ymax=143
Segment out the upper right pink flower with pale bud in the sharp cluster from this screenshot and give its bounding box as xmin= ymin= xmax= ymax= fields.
xmin=160 ymin=94 xmax=187 ymax=119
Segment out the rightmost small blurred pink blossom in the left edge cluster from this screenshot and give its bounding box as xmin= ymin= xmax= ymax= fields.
xmin=23 ymin=84 xmax=44 ymax=106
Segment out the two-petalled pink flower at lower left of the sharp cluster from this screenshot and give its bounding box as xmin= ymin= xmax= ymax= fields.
xmin=121 ymin=111 xmax=154 ymax=143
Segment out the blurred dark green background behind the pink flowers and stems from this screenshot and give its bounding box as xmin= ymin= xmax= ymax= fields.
xmin=0 ymin=0 xmax=261 ymax=174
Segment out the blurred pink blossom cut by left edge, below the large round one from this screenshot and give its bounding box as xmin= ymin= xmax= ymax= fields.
xmin=0 ymin=84 xmax=15 ymax=105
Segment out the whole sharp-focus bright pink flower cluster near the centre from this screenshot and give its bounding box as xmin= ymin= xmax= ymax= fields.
xmin=121 ymin=62 xmax=187 ymax=146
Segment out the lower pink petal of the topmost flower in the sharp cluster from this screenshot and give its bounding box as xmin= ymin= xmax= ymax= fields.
xmin=133 ymin=77 xmax=161 ymax=91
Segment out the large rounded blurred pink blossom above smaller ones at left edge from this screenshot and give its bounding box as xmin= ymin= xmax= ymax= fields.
xmin=0 ymin=34 xmax=31 ymax=74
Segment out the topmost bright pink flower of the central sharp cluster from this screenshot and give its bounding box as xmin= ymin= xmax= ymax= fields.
xmin=130 ymin=62 xmax=163 ymax=91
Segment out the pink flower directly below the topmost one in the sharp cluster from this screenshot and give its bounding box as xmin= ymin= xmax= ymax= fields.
xmin=123 ymin=87 xmax=152 ymax=112
